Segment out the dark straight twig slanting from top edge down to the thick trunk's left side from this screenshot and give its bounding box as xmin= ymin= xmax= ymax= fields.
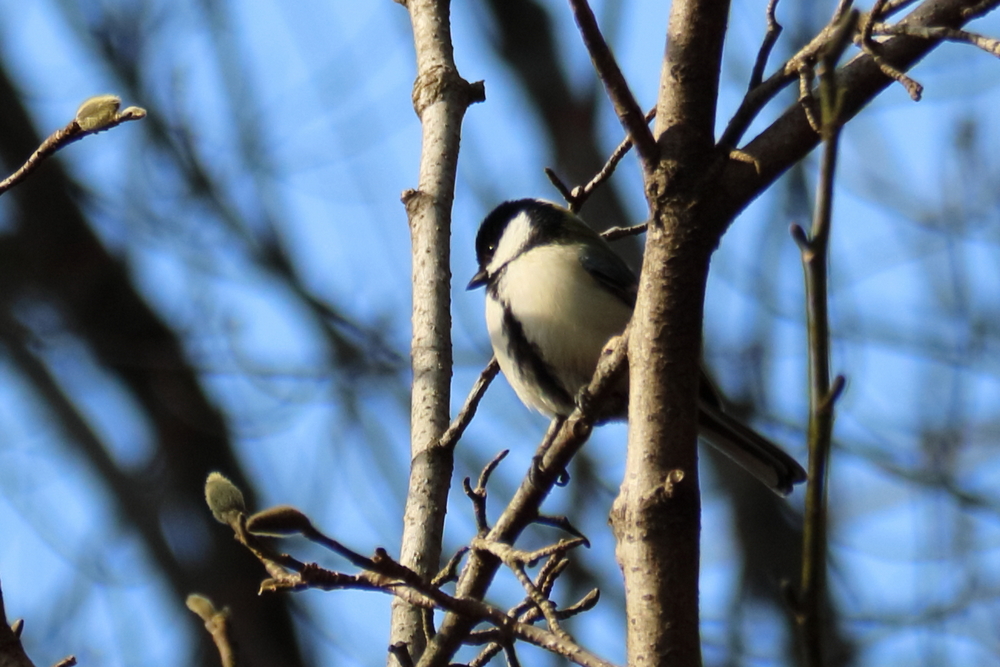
xmin=569 ymin=0 xmax=660 ymax=174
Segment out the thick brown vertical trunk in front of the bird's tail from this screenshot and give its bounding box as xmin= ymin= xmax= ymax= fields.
xmin=611 ymin=0 xmax=729 ymax=667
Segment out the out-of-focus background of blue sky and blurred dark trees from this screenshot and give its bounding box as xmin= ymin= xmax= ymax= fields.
xmin=0 ymin=0 xmax=1000 ymax=666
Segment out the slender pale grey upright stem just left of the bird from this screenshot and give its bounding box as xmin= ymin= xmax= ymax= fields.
xmin=389 ymin=0 xmax=485 ymax=664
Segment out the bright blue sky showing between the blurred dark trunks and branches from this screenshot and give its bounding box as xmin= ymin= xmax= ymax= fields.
xmin=0 ymin=0 xmax=1000 ymax=666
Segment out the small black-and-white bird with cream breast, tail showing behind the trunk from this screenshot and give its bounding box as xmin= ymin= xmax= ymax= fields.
xmin=467 ymin=199 xmax=807 ymax=496
